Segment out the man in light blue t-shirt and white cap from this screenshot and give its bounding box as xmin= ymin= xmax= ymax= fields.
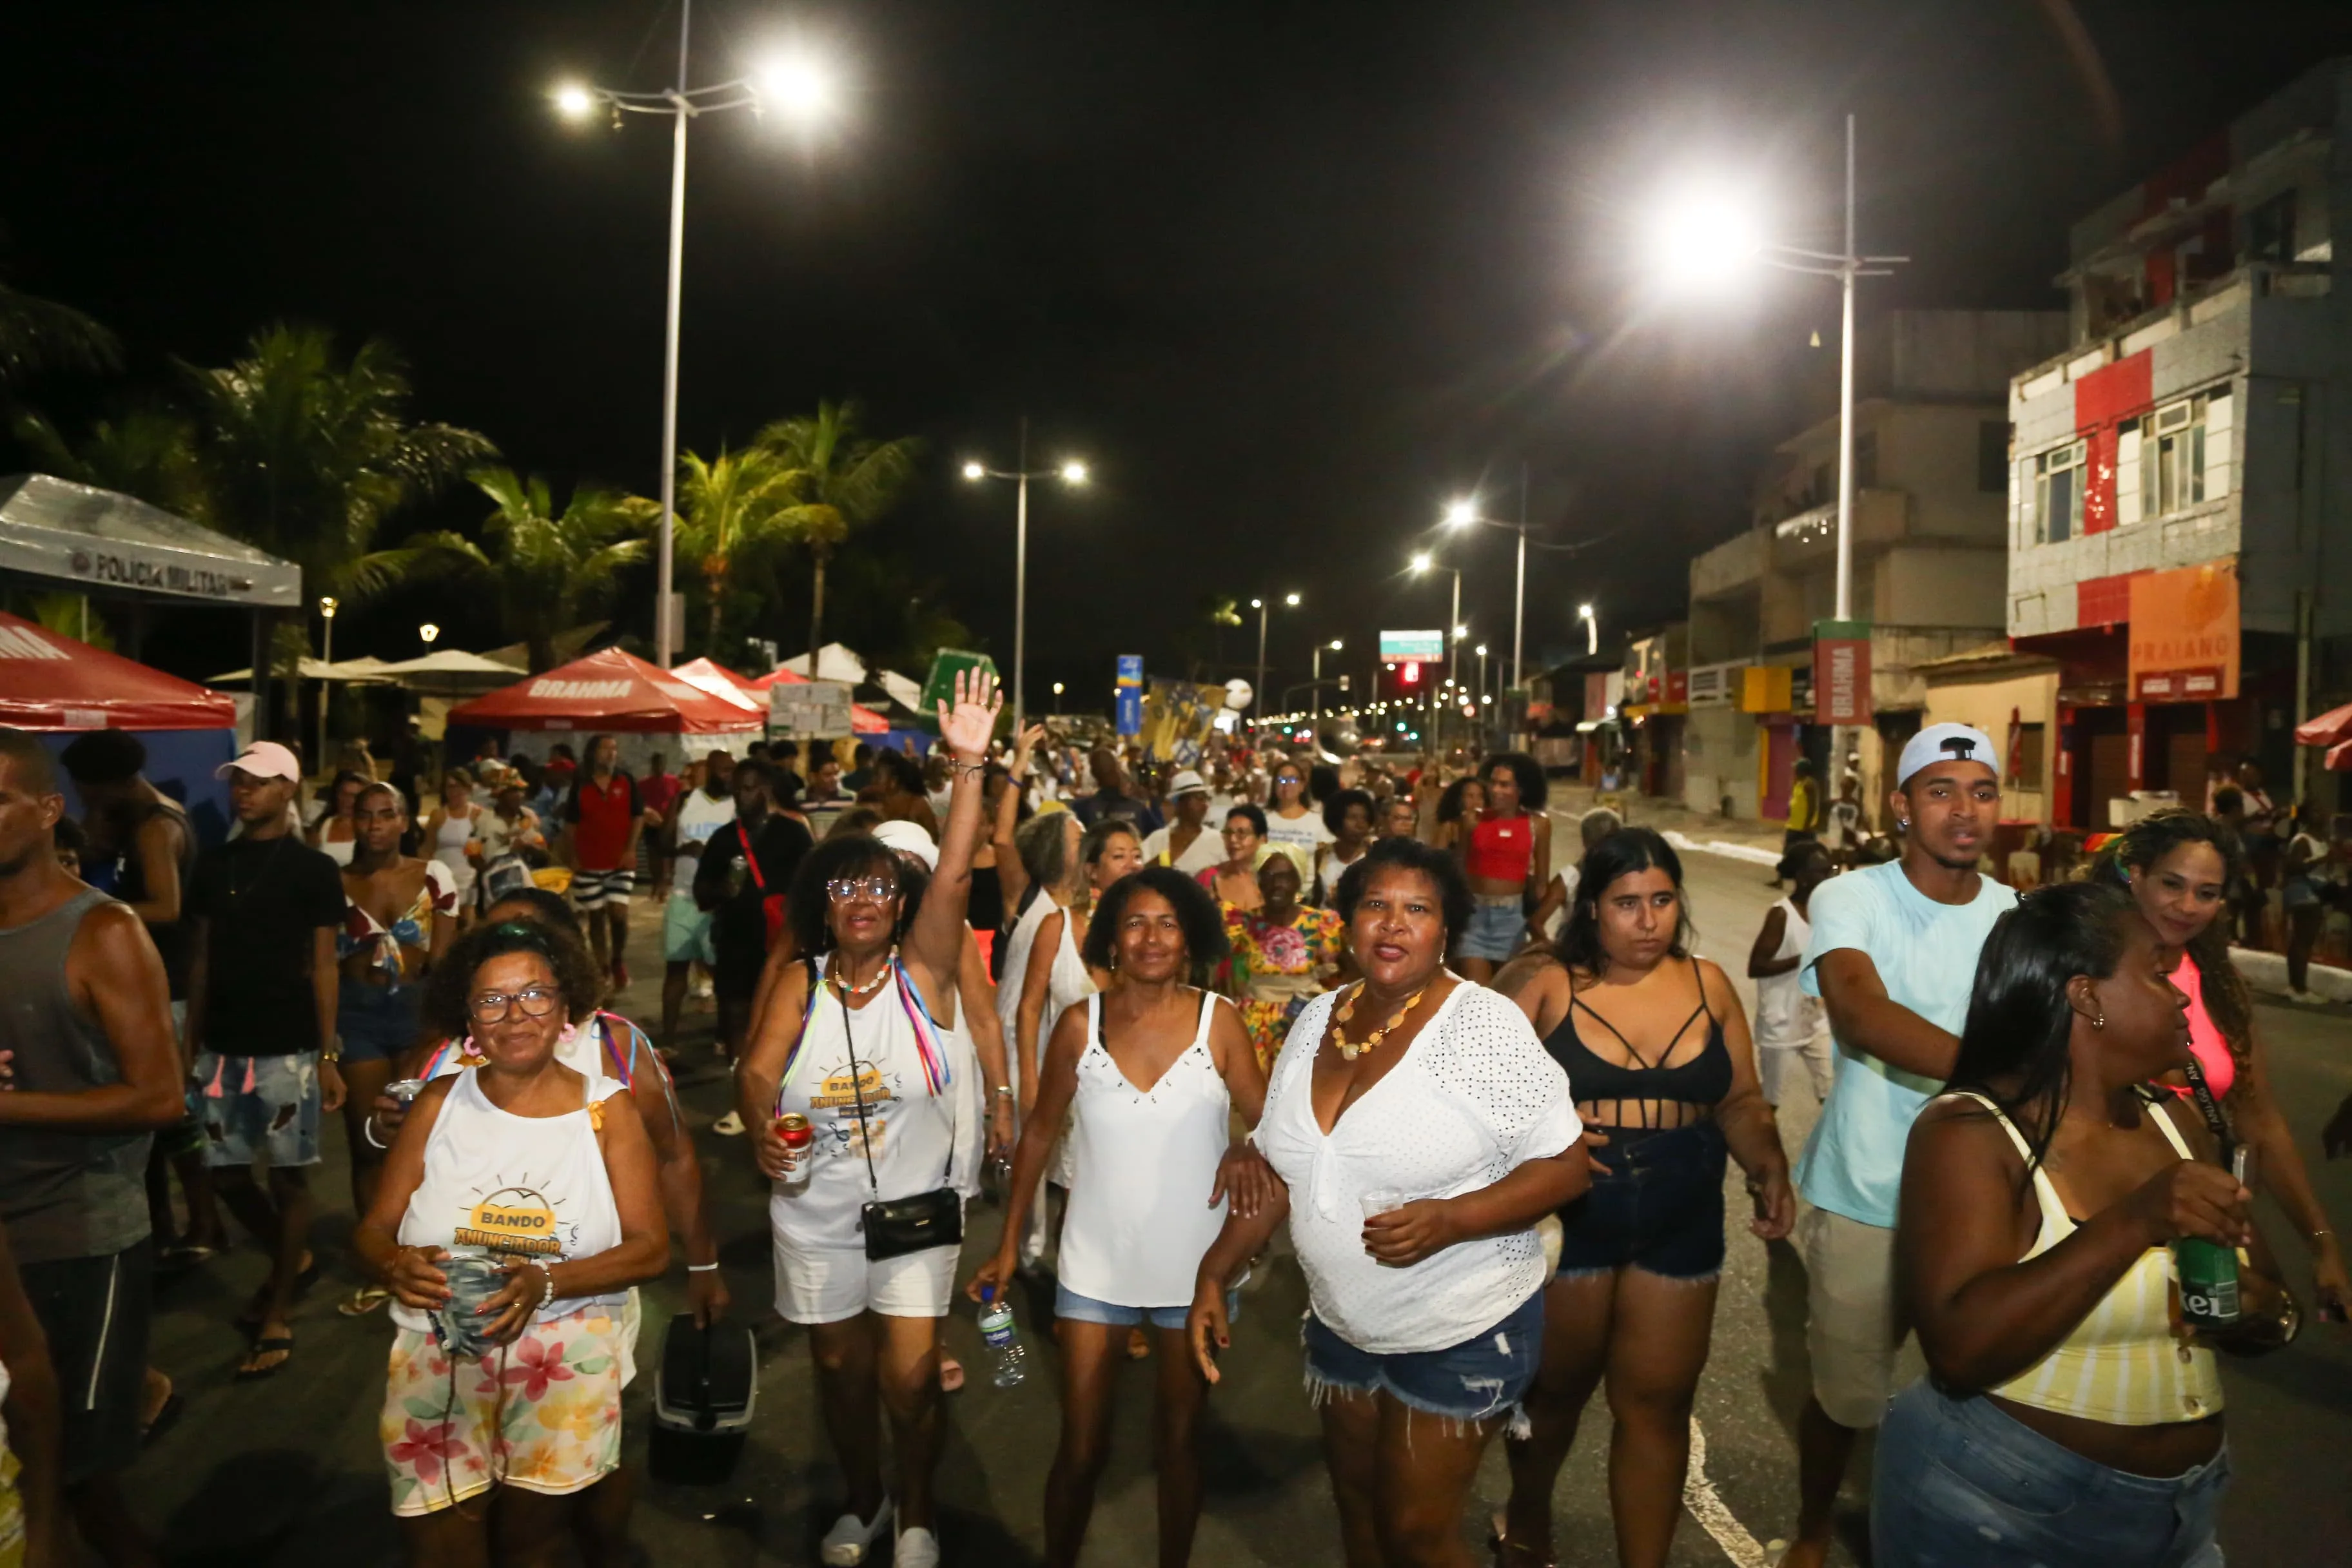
xmin=1781 ymin=724 xmax=2018 ymax=1568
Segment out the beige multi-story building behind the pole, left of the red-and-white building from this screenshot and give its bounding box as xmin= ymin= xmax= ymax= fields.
xmin=1680 ymin=310 xmax=2065 ymax=818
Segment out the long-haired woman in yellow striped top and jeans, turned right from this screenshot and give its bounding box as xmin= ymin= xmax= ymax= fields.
xmin=1870 ymin=879 xmax=2295 ymax=1568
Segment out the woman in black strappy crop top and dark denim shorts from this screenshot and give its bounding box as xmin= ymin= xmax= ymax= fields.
xmin=1496 ymin=827 xmax=1797 ymax=1568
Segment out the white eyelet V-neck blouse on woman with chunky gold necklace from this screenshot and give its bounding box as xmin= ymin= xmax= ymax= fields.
xmin=1253 ymin=980 xmax=1583 ymax=1357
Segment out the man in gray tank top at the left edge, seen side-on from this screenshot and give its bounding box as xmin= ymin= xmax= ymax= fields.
xmin=0 ymin=729 xmax=181 ymax=1563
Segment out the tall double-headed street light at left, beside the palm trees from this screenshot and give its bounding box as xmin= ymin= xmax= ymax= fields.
xmin=553 ymin=0 xmax=839 ymax=674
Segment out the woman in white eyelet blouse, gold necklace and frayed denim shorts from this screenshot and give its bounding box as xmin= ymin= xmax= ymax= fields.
xmin=1188 ymin=839 xmax=1587 ymax=1568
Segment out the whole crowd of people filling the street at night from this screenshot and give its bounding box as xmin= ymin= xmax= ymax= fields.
xmin=0 ymin=700 xmax=2352 ymax=1568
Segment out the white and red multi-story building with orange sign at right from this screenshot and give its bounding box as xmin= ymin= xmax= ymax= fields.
xmin=1984 ymin=59 xmax=2352 ymax=830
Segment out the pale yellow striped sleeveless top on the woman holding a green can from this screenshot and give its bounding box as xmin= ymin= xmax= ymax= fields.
xmin=1966 ymin=1093 xmax=2220 ymax=1427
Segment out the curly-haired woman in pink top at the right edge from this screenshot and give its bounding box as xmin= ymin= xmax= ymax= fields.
xmin=2091 ymin=808 xmax=2352 ymax=1314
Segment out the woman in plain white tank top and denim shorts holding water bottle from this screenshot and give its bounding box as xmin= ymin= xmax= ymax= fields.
xmin=966 ymin=865 xmax=1266 ymax=1565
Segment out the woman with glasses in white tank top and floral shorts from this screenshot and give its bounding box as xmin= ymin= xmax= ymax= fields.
xmin=353 ymin=921 xmax=671 ymax=1563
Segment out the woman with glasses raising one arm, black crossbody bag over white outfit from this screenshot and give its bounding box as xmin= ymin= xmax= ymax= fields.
xmin=736 ymin=670 xmax=1002 ymax=1568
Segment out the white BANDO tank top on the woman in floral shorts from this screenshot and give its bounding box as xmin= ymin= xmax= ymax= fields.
xmin=393 ymin=1072 xmax=628 ymax=1333
